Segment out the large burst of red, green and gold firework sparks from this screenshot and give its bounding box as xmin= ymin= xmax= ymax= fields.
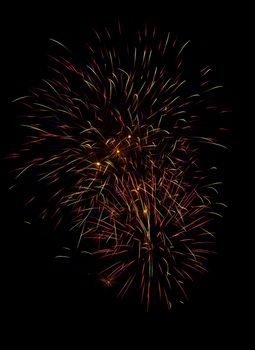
xmin=10 ymin=26 xmax=228 ymax=309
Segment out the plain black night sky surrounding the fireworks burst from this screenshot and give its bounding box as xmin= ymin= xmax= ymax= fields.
xmin=0 ymin=1 xmax=245 ymax=349
